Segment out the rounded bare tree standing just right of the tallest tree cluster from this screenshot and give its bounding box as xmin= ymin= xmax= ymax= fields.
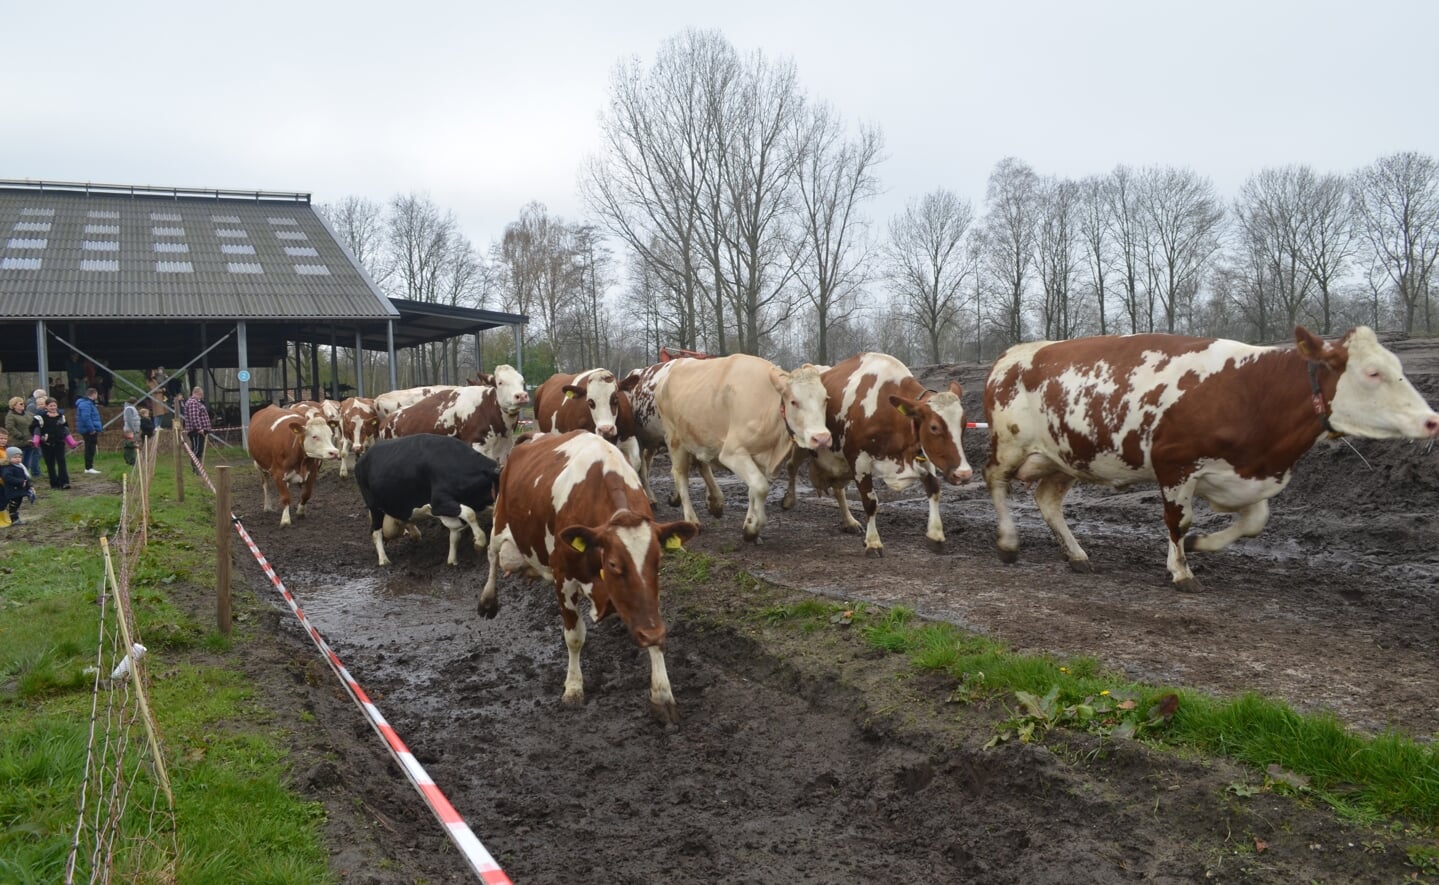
xmin=886 ymin=190 xmax=974 ymax=363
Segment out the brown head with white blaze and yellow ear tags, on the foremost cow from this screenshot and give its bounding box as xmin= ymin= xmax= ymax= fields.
xmin=558 ymin=509 xmax=699 ymax=648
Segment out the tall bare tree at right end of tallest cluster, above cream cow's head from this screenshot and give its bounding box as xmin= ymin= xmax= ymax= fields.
xmin=793 ymin=104 xmax=884 ymax=364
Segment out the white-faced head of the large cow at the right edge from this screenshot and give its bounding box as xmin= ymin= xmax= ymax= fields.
xmin=1294 ymin=325 xmax=1439 ymax=439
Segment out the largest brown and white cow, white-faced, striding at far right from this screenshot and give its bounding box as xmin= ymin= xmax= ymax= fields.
xmin=984 ymin=327 xmax=1439 ymax=590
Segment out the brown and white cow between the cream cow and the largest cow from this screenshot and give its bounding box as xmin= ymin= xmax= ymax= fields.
xmin=810 ymin=353 xmax=974 ymax=555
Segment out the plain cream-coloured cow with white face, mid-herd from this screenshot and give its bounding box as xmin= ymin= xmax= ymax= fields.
xmin=655 ymin=354 xmax=830 ymax=541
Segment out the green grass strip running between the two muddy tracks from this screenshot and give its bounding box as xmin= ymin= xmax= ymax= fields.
xmin=690 ymin=570 xmax=1439 ymax=827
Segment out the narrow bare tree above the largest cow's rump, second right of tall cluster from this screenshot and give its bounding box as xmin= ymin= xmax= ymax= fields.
xmin=980 ymin=157 xmax=1039 ymax=347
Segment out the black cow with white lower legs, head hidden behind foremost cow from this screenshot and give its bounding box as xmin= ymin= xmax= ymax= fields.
xmin=355 ymin=433 xmax=499 ymax=566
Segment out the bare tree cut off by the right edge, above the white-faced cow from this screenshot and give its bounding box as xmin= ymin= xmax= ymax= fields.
xmin=1353 ymin=151 xmax=1439 ymax=332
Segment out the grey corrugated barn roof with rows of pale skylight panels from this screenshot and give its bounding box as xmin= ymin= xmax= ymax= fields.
xmin=0 ymin=181 xmax=397 ymax=321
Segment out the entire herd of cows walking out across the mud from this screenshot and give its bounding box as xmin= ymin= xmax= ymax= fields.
xmin=241 ymin=327 xmax=1439 ymax=722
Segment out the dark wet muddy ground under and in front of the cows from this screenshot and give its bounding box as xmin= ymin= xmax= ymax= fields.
xmin=205 ymin=335 xmax=1439 ymax=884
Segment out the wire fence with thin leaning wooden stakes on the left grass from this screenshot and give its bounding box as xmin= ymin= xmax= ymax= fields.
xmin=65 ymin=437 xmax=180 ymax=884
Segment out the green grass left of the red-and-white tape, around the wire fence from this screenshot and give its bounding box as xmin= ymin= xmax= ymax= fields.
xmin=0 ymin=455 xmax=332 ymax=884
